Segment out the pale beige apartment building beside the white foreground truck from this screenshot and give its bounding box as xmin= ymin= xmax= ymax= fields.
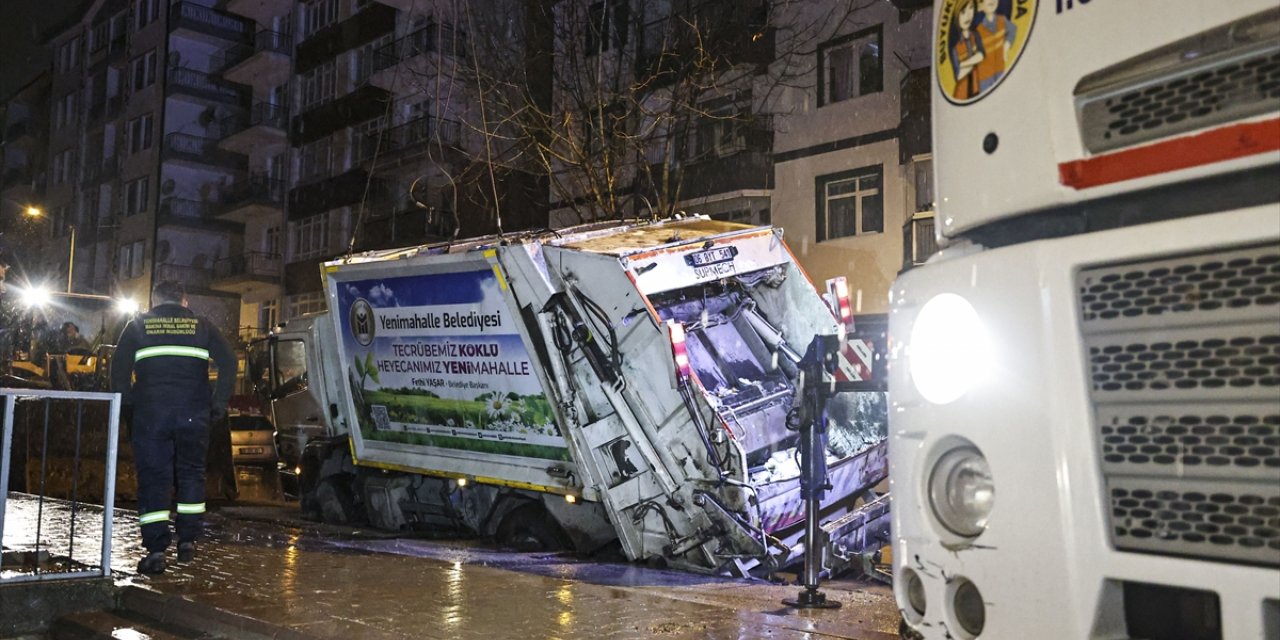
xmin=772 ymin=3 xmax=936 ymax=314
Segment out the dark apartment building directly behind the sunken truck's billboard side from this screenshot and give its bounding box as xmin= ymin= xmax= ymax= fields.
xmin=264 ymin=0 xmax=547 ymax=317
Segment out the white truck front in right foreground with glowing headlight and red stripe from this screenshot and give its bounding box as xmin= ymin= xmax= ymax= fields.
xmin=890 ymin=0 xmax=1280 ymax=640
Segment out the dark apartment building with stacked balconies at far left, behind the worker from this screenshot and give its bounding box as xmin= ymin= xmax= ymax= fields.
xmin=35 ymin=0 xmax=252 ymax=335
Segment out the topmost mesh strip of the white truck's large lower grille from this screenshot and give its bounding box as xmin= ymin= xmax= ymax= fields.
xmin=1080 ymin=247 xmax=1280 ymax=323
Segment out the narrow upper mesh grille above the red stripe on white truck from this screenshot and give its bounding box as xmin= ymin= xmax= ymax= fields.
xmin=1076 ymin=44 xmax=1280 ymax=154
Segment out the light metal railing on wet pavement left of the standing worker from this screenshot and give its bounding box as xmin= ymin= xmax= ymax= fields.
xmin=0 ymin=388 xmax=120 ymax=584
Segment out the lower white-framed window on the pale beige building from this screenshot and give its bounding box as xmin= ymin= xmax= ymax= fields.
xmin=817 ymin=166 xmax=884 ymax=242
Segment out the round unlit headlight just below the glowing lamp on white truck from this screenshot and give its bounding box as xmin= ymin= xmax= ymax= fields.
xmin=929 ymin=447 xmax=996 ymax=538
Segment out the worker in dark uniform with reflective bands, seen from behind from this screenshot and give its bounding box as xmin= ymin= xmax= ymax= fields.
xmin=111 ymin=280 xmax=236 ymax=573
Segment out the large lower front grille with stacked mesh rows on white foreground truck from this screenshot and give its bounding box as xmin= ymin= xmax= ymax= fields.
xmin=1076 ymin=244 xmax=1280 ymax=566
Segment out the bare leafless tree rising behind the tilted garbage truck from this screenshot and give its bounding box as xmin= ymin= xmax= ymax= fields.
xmin=450 ymin=0 xmax=890 ymax=227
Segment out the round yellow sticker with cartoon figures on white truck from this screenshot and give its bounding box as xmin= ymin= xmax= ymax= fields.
xmin=934 ymin=0 xmax=1038 ymax=105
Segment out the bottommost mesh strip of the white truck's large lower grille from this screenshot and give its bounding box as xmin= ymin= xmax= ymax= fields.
xmin=1108 ymin=479 xmax=1280 ymax=566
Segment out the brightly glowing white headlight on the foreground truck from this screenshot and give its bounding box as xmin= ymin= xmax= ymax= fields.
xmin=908 ymin=293 xmax=991 ymax=404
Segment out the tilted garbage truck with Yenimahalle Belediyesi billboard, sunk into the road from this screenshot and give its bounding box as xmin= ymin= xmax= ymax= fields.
xmin=260 ymin=218 xmax=888 ymax=575
